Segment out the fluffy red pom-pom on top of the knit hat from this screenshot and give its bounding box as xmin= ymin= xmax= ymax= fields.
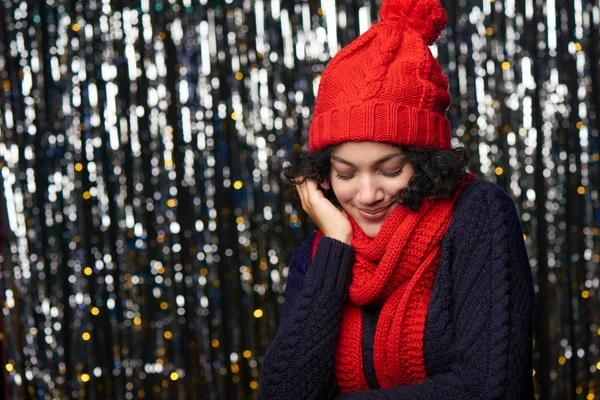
xmin=379 ymin=0 xmax=447 ymax=46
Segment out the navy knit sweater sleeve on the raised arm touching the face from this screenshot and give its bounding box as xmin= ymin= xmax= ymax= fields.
xmin=260 ymin=237 xmax=354 ymax=400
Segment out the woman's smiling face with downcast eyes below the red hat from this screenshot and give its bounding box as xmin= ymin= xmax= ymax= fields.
xmin=330 ymin=142 xmax=415 ymax=238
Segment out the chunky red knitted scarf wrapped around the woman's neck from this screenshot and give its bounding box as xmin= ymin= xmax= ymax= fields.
xmin=313 ymin=174 xmax=474 ymax=392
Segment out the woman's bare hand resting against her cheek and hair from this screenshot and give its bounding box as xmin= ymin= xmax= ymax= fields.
xmin=296 ymin=179 xmax=352 ymax=244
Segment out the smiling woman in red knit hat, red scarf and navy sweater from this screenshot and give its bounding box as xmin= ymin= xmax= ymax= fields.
xmin=260 ymin=0 xmax=533 ymax=400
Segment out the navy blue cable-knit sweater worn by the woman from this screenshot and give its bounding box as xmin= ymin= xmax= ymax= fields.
xmin=260 ymin=180 xmax=534 ymax=400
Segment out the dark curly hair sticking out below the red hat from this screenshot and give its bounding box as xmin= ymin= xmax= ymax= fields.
xmin=283 ymin=145 xmax=469 ymax=211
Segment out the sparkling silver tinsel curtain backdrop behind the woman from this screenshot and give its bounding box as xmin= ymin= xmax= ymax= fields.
xmin=0 ymin=0 xmax=600 ymax=400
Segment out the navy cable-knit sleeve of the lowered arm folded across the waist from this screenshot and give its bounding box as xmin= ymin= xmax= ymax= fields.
xmin=336 ymin=183 xmax=534 ymax=400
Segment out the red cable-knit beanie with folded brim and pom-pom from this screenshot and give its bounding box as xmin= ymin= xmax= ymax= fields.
xmin=308 ymin=0 xmax=451 ymax=152
